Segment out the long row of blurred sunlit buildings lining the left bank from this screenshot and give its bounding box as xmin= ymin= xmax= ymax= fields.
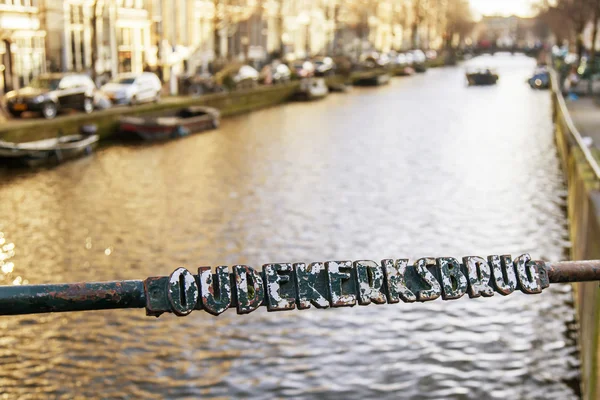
xmin=0 ymin=0 xmax=447 ymax=91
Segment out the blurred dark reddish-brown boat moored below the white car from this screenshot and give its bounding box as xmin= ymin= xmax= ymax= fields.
xmin=119 ymin=106 xmax=221 ymax=140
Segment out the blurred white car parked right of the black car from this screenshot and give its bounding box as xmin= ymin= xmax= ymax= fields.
xmin=101 ymin=72 xmax=162 ymax=105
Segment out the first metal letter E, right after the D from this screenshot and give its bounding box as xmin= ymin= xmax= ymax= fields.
xmin=263 ymin=264 xmax=296 ymax=311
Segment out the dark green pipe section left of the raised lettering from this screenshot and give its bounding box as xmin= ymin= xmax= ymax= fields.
xmin=0 ymin=281 xmax=146 ymax=315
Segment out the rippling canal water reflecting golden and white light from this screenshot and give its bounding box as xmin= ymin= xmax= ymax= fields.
xmin=0 ymin=54 xmax=579 ymax=400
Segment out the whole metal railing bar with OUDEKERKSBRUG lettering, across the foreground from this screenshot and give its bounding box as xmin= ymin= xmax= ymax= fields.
xmin=0 ymin=254 xmax=600 ymax=316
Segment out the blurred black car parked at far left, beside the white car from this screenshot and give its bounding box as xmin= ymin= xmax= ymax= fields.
xmin=6 ymin=74 xmax=96 ymax=119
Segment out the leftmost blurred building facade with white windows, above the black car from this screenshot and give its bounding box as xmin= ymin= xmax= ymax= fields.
xmin=0 ymin=0 xmax=46 ymax=93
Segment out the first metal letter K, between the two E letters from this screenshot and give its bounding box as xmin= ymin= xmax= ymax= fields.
xmin=294 ymin=262 xmax=329 ymax=310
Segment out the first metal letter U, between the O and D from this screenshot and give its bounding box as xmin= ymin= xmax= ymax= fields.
xmin=198 ymin=266 xmax=231 ymax=315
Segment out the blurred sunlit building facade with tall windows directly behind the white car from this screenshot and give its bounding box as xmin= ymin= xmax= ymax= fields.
xmin=39 ymin=0 xmax=152 ymax=83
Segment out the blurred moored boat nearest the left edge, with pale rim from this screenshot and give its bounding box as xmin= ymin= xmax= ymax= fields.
xmin=0 ymin=126 xmax=99 ymax=167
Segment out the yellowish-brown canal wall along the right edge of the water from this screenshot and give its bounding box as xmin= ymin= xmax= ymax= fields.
xmin=550 ymin=70 xmax=600 ymax=399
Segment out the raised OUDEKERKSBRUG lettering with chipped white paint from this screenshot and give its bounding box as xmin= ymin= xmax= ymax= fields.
xmin=155 ymin=254 xmax=549 ymax=315
